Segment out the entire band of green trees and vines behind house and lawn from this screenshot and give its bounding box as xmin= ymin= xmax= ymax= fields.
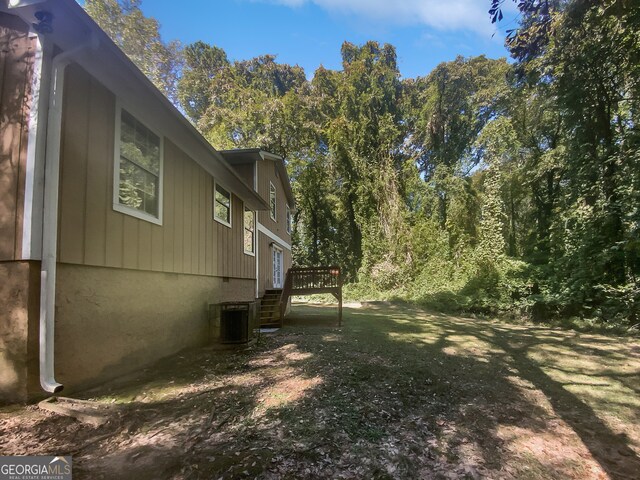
xmin=86 ymin=0 xmax=640 ymax=325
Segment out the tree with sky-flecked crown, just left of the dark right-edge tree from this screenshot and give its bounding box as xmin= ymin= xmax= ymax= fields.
xmin=409 ymin=56 xmax=509 ymax=247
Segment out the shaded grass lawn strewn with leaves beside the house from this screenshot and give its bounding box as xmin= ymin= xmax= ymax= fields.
xmin=0 ymin=305 xmax=640 ymax=480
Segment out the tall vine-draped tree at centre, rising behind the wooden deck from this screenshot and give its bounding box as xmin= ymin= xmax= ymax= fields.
xmin=322 ymin=42 xmax=404 ymax=282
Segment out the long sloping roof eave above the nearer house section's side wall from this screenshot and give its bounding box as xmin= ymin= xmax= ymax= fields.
xmin=0 ymin=0 xmax=269 ymax=210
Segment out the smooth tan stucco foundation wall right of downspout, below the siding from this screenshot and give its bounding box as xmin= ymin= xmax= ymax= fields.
xmin=55 ymin=264 xmax=255 ymax=393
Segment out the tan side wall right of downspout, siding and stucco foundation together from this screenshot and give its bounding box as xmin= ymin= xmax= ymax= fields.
xmin=40 ymin=65 xmax=256 ymax=391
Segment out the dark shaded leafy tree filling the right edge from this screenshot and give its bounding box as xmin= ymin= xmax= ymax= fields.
xmin=492 ymin=0 xmax=640 ymax=317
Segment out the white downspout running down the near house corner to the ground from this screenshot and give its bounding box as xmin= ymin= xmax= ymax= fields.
xmin=40 ymin=38 xmax=95 ymax=393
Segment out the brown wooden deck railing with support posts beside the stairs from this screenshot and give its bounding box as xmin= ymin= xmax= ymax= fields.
xmin=280 ymin=266 xmax=342 ymax=325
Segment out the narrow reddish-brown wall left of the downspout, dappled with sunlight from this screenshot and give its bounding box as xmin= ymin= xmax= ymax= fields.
xmin=0 ymin=13 xmax=40 ymax=403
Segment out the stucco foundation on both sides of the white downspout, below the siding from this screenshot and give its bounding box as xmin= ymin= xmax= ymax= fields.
xmin=0 ymin=262 xmax=255 ymax=403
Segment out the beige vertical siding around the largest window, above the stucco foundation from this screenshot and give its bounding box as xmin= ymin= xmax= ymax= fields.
xmin=58 ymin=65 xmax=255 ymax=278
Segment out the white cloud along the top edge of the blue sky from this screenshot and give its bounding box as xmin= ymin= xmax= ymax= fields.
xmin=263 ymin=0 xmax=500 ymax=34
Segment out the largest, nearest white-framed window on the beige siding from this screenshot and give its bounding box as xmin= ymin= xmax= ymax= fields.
xmin=113 ymin=109 xmax=162 ymax=224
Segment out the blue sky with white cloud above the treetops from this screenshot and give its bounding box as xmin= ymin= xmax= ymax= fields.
xmin=142 ymin=0 xmax=514 ymax=78
